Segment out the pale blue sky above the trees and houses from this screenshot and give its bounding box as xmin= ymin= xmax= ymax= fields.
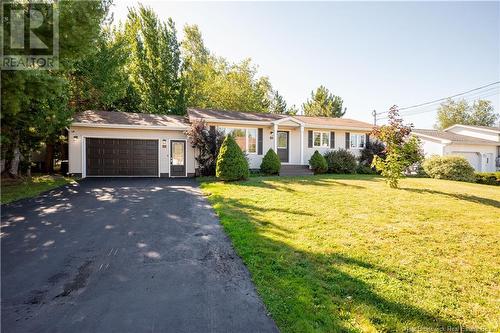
xmin=112 ymin=1 xmax=500 ymax=128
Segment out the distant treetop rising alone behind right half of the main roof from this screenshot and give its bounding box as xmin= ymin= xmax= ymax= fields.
xmin=302 ymin=86 xmax=346 ymax=118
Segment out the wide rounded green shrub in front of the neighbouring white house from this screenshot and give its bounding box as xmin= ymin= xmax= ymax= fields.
xmin=422 ymin=156 xmax=476 ymax=182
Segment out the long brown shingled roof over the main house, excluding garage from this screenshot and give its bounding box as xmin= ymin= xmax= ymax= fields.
xmin=188 ymin=108 xmax=373 ymax=130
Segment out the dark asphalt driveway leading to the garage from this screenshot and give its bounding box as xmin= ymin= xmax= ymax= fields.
xmin=1 ymin=178 xmax=277 ymax=332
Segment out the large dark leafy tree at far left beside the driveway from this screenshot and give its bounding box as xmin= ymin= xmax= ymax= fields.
xmin=1 ymin=0 xmax=110 ymax=176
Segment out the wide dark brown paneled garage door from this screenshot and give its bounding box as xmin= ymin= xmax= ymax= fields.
xmin=85 ymin=138 xmax=158 ymax=177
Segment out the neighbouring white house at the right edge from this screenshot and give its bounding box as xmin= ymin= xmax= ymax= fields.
xmin=413 ymin=125 xmax=500 ymax=172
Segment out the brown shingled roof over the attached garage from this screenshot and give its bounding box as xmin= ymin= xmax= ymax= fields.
xmin=73 ymin=110 xmax=189 ymax=129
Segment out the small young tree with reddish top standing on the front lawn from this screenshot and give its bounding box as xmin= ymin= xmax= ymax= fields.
xmin=372 ymin=106 xmax=423 ymax=188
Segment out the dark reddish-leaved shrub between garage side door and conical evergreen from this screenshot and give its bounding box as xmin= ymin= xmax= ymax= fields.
xmin=186 ymin=121 xmax=224 ymax=176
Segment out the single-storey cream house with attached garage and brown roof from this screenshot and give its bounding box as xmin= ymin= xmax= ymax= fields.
xmin=68 ymin=109 xmax=372 ymax=177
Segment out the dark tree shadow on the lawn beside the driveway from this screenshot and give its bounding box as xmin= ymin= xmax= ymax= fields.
xmin=210 ymin=191 xmax=459 ymax=332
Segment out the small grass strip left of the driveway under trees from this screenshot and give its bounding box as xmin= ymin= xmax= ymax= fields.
xmin=1 ymin=175 xmax=73 ymax=204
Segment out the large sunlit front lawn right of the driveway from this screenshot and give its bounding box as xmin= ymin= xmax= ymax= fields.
xmin=202 ymin=175 xmax=500 ymax=332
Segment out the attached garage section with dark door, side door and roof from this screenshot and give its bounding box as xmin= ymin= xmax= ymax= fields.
xmin=68 ymin=111 xmax=196 ymax=178
